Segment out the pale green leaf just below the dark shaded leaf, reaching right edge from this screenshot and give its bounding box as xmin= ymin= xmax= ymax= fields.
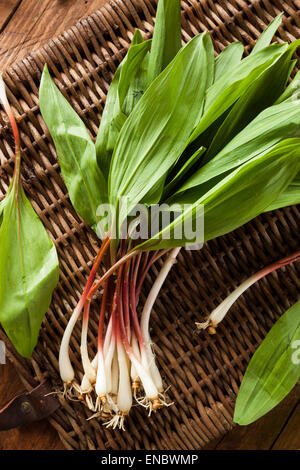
xmin=178 ymin=98 xmax=300 ymax=194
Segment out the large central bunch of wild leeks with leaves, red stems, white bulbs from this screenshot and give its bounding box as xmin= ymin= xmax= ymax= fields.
xmin=40 ymin=0 xmax=300 ymax=428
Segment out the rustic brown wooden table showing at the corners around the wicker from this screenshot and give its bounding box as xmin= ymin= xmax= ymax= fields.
xmin=0 ymin=0 xmax=300 ymax=450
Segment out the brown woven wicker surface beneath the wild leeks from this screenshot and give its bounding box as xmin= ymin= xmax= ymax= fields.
xmin=0 ymin=0 xmax=300 ymax=449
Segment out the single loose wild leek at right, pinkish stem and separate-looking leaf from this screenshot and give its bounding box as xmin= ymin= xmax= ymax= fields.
xmin=196 ymin=251 xmax=300 ymax=425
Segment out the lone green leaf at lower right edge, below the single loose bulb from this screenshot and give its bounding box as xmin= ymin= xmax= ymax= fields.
xmin=233 ymin=302 xmax=300 ymax=425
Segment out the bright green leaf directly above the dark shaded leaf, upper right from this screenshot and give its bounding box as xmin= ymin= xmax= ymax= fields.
xmin=188 ymin=44 xmax=288 ymax=143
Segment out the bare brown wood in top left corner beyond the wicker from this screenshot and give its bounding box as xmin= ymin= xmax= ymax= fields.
xmin=0 ymin=0 xmax=106 ymax=70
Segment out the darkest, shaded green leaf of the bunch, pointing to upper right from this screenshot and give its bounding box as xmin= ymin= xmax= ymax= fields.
xmin=204 ymin=41 xmax=299 ymax=162
